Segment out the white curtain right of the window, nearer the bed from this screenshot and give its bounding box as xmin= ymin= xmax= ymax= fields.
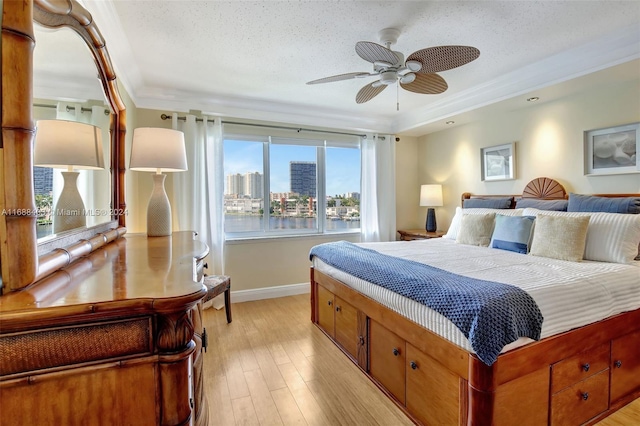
xmin=360 ymin=134 xmax=396 ymax=242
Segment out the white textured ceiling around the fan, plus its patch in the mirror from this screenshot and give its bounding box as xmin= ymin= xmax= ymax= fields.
xmin=34 ymin=0 xmax=640 ymax=135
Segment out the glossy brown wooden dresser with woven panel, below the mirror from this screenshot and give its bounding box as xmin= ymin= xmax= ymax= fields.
xmin=0 ymin=232 xmax=208 ymax=425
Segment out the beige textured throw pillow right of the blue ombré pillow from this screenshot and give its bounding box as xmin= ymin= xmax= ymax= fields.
xmin=529 ymin=214 xmax=590 ymax=262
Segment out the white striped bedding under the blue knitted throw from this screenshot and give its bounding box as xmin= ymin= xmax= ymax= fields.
xmin=313 ymin=238 xmax=640 ymax=352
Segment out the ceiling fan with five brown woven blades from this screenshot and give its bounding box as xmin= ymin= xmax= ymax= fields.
xmin=307 ymin=28 xmax=480 ymax=104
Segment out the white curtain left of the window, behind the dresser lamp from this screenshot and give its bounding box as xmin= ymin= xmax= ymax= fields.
xmin=171 ymin=113 xmax=224 ymax=275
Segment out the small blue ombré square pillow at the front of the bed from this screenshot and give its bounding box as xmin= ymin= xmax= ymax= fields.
xmin=489 ymin=214 xmax=536 ymax=254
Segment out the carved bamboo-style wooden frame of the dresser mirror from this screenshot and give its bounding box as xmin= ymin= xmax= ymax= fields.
xmin=0 ymin=0 xmax=126 ymax=292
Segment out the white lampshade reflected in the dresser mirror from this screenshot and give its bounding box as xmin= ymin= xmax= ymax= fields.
xmin=33 ymin=120 xmax=104 ymax=170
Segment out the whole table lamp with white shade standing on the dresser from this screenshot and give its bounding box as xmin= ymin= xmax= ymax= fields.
xmin=129 ymin=127 xmax=187 ymax=237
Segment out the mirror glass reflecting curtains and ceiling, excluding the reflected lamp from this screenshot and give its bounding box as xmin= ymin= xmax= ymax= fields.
xmin=33 ymin=25 xmax=112 ymax=242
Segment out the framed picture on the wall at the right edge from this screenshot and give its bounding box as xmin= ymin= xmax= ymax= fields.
xmin=584 ymin=123 xmax=640 ymax=175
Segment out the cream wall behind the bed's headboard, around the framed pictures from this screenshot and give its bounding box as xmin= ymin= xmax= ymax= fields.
xmin=412 ymin=75 xmax=640 ymax=229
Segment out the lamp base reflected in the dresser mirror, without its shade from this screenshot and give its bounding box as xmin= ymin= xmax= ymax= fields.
xmin=53 ymin=172 xmax=87 ymax=234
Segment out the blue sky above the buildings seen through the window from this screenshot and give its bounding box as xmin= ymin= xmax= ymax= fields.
xmin=224 ymin=141 xmax=360 ymax=195
